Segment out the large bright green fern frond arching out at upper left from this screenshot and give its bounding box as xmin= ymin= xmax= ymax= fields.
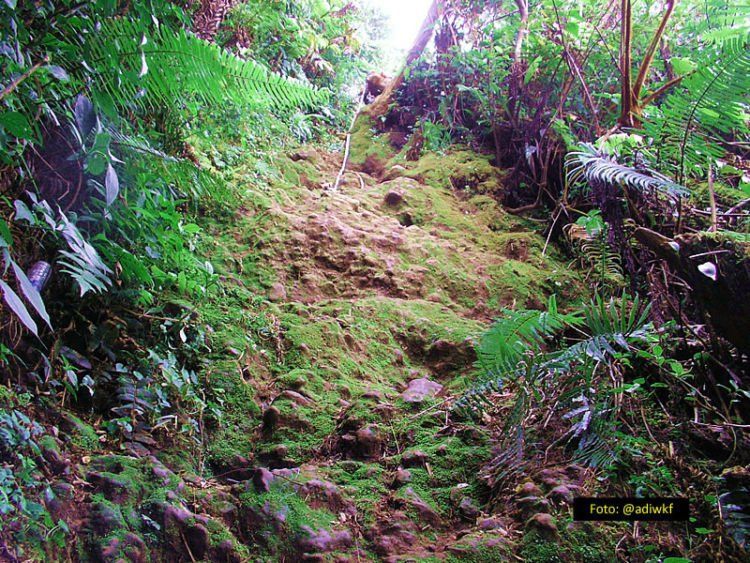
xmin=83 ymin=19 xmax=324 ymax=113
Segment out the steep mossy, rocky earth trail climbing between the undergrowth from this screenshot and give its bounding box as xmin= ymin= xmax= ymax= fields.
xmin=55 ymin=138 xmax=585 ymax=562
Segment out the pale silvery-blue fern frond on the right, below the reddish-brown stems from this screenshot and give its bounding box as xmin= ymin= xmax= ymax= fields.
xmin=565 ymin=143 xmax=689 ymax=197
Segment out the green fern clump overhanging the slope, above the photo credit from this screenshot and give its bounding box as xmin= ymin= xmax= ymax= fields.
xmin=453 ymin=296 xmax=652 ymax=474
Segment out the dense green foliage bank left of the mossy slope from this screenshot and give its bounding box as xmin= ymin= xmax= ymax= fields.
xmin=0 ymin=1 xmax=382 ymax=557
